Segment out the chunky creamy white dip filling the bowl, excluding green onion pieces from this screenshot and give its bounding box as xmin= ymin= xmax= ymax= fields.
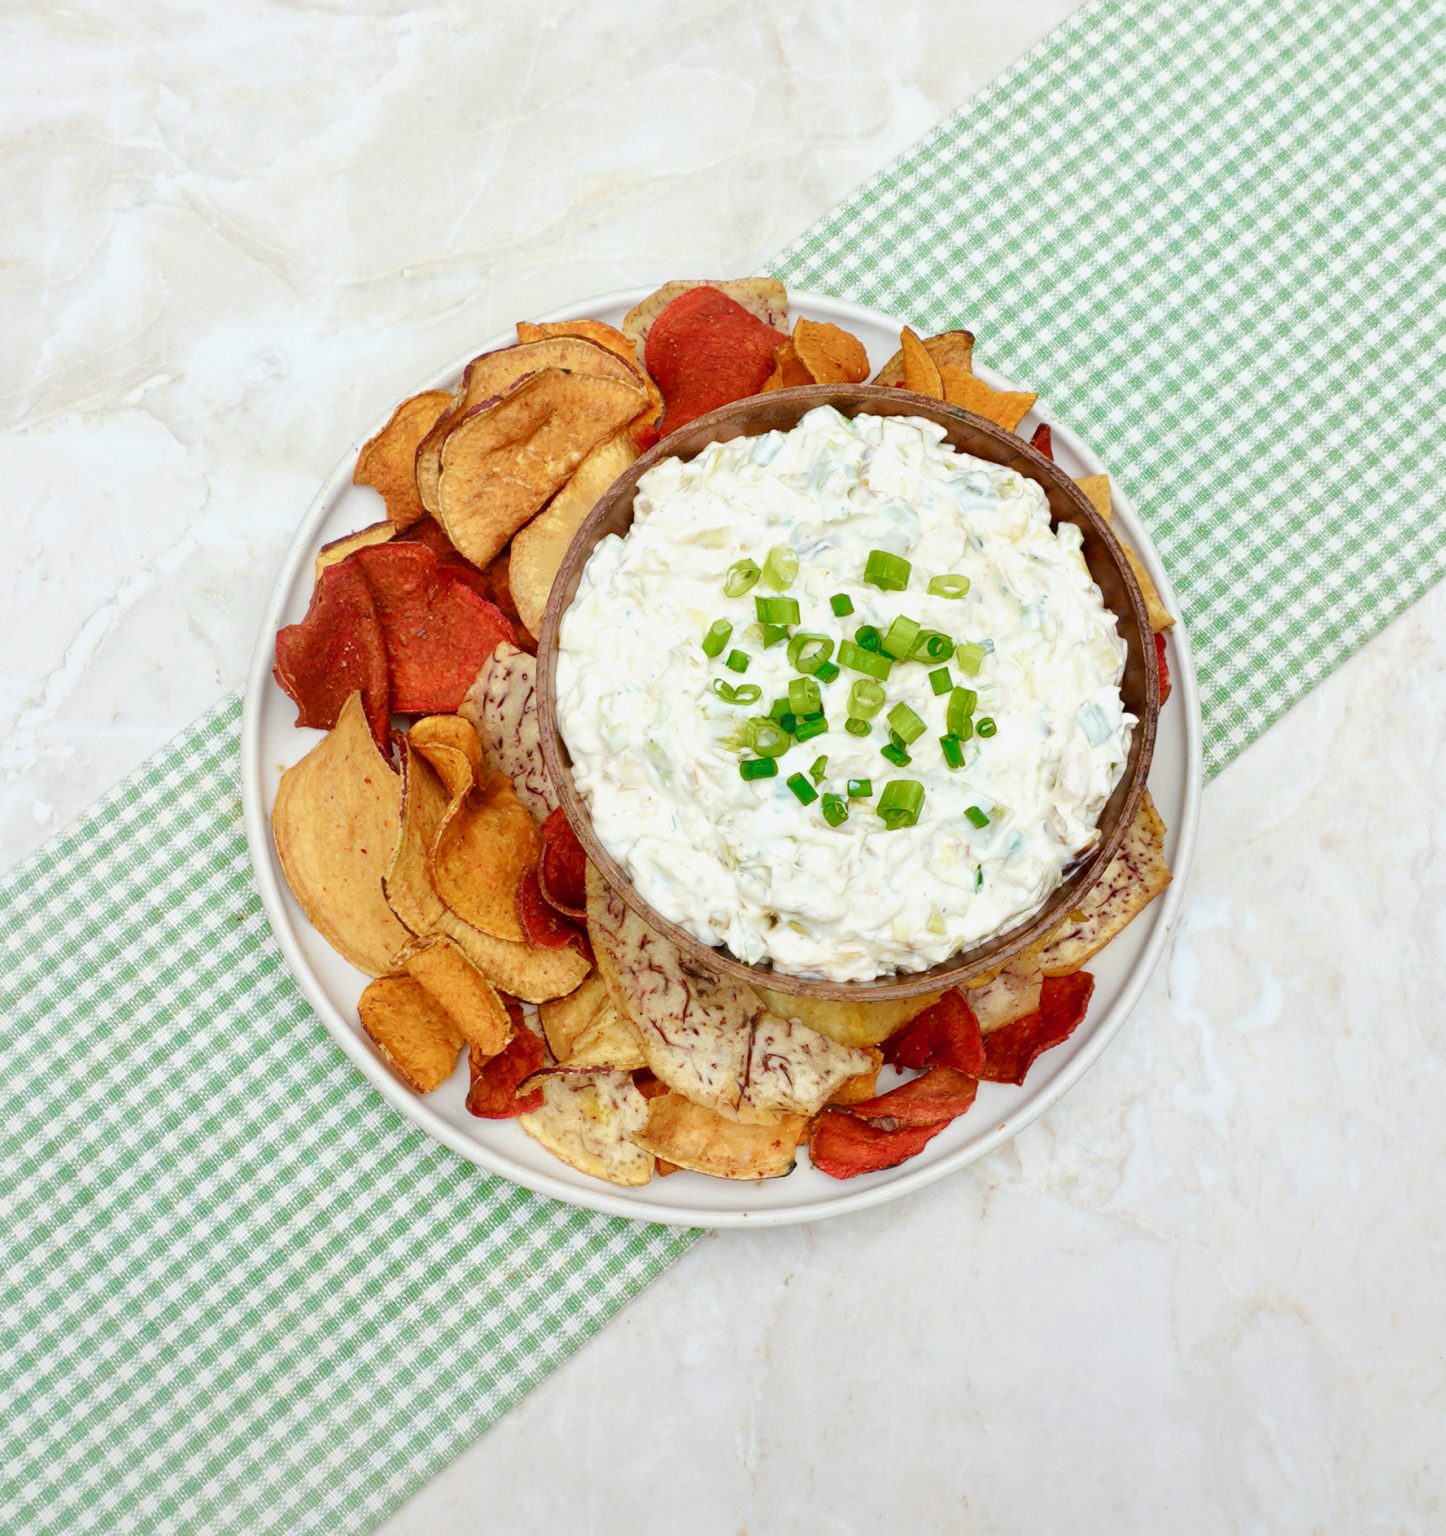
xmin=558 ymin=407 xmax=1134 ymax=980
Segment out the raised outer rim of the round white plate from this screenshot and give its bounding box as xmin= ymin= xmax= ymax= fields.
xmin=240 ymin=284 xmax=1203 ymax=1229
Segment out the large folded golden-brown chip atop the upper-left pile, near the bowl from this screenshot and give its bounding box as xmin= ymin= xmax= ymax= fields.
xmin=435 ymin=368 xmax=647 ymax=567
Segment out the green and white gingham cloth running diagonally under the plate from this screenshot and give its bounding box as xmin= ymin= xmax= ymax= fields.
xmin=0 ymin=0 xmax=1446 ymax=1536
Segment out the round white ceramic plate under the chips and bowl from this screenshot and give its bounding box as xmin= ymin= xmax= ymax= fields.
xmin=241 ymin=289 xmax=1200 ymax=1227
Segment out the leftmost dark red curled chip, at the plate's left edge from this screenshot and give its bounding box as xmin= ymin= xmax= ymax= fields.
xmin=272 ymin=559 xmax=392 ymax=753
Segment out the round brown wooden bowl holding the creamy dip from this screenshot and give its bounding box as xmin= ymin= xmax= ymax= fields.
xmin=538 ymin=384 xmax=1160 ymax=1001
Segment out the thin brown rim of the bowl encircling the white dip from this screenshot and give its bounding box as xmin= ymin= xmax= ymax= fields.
xmin=536 ymin=384 xmax=1160 ymax=1003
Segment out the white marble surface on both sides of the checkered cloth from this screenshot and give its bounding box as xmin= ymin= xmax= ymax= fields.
xmin=0 ymin=0 xmax=1446 ymax=1536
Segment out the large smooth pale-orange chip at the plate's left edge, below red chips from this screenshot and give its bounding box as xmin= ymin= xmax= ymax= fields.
xmin=270 ymin=693 xmax=407 ymax=975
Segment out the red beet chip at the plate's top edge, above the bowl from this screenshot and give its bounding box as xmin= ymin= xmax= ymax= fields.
xmin=644 ymin=287 xmax=788 ymax=436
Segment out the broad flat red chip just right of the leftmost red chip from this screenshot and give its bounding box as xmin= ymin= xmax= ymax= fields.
xmin=351 ymin=541 xmax=515 ymax=714
